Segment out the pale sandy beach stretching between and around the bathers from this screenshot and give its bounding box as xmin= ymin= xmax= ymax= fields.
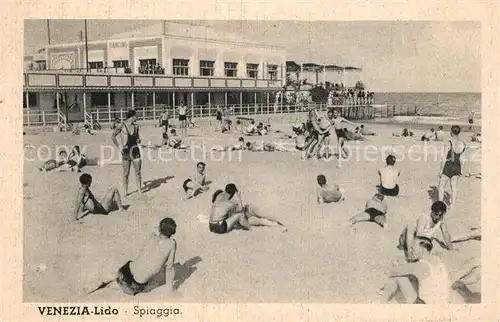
xmin=23 ymin=116 xmax=481 ymax=303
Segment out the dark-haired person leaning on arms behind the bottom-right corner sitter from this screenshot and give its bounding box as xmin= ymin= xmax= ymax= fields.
xmin=398 ymin=201 xmax=453 ymax=254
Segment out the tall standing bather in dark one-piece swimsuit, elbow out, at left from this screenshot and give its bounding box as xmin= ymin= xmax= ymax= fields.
xmin=111 ymin=110 xmax=142 ymax=197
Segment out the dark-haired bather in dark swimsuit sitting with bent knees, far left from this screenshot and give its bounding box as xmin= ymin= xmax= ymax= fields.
xmin=74 ymin=173 xmax=125 ymax=220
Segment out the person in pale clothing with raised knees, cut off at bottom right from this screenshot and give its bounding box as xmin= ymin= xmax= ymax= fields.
xmin=376 ymin=237 xmax=451 ymax=304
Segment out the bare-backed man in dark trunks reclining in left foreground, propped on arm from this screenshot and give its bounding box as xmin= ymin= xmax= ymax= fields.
xmin=89 ymin=217 xmax=177 ymax=296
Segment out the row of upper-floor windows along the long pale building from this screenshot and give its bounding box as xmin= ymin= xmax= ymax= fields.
xmin=89 ymin=59 xmax=278 ymax=79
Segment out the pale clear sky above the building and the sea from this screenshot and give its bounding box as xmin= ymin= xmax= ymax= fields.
xmin=24 ymin=20 xmax=481 ymax=92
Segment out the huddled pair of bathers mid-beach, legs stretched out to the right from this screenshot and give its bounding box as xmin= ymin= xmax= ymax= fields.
xmin=209 ymin=183 xmax=286 ymax=234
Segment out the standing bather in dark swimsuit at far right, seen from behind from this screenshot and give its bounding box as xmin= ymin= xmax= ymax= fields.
xmin=438 ymin=125 xmax=467 ymax=210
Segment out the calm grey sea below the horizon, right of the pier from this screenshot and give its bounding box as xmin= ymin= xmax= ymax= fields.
xmin=374 ymin=93 xmax=481 ymax=119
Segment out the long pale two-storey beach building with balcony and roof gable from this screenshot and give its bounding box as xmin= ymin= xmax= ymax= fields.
xmin=23 ymin=22 xmax=286 ymax=124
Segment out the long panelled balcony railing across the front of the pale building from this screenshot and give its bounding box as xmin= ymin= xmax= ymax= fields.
xmin=23 ymin=70 xmax=281 ymax=92
